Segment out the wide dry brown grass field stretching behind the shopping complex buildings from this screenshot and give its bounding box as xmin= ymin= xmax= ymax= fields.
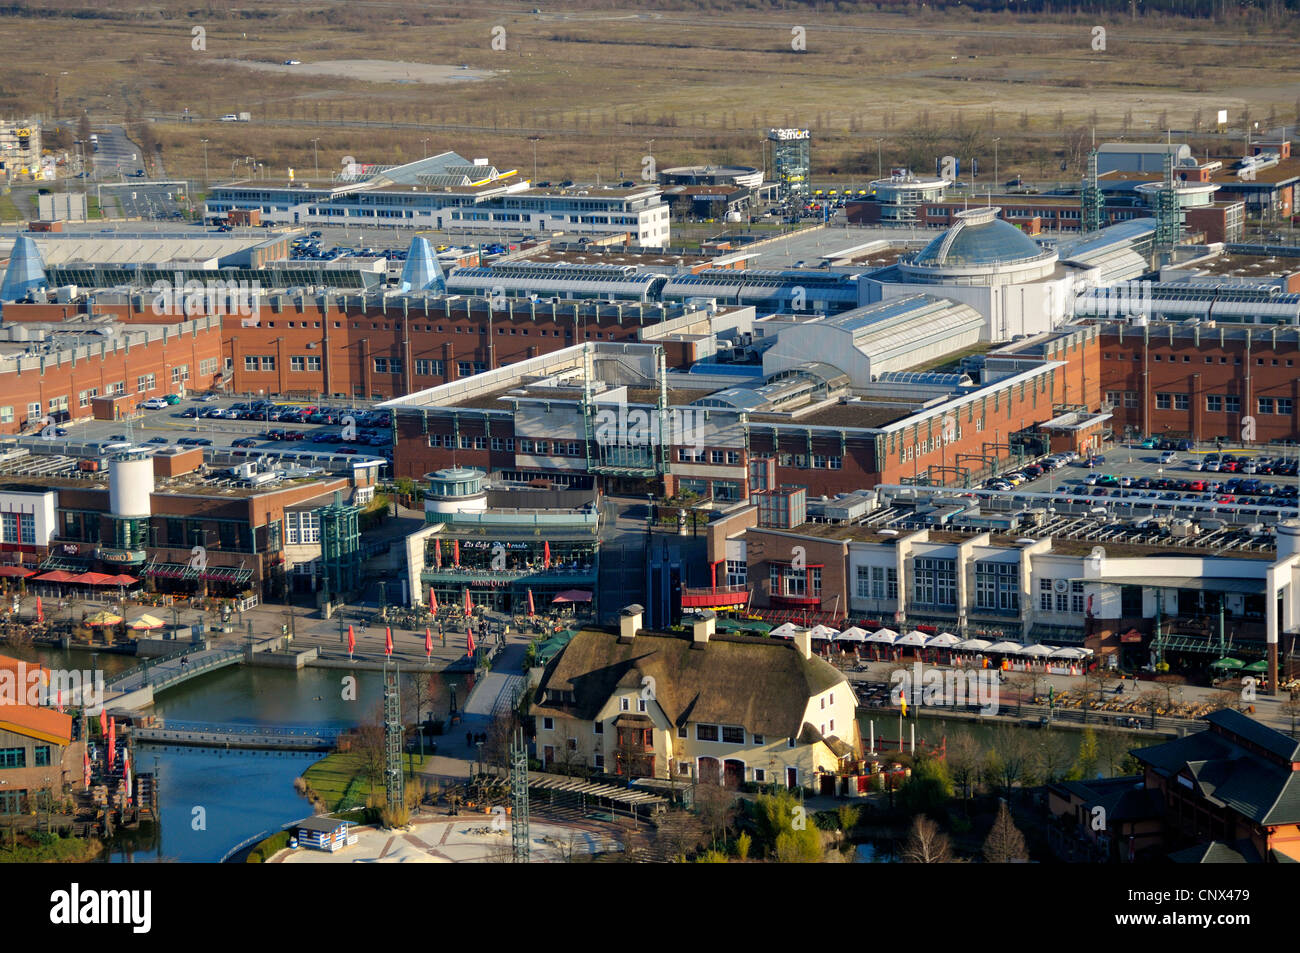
xmin=0 ymin=0 xmax=1300 ymax=182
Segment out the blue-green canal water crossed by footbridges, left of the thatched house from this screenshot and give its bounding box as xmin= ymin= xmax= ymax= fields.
xmin=27 ymin=649 xmax=465 ymax=863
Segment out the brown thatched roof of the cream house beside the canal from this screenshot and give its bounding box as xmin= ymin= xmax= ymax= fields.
xmin=536 ymin=629 xmax=850 ymax=737
